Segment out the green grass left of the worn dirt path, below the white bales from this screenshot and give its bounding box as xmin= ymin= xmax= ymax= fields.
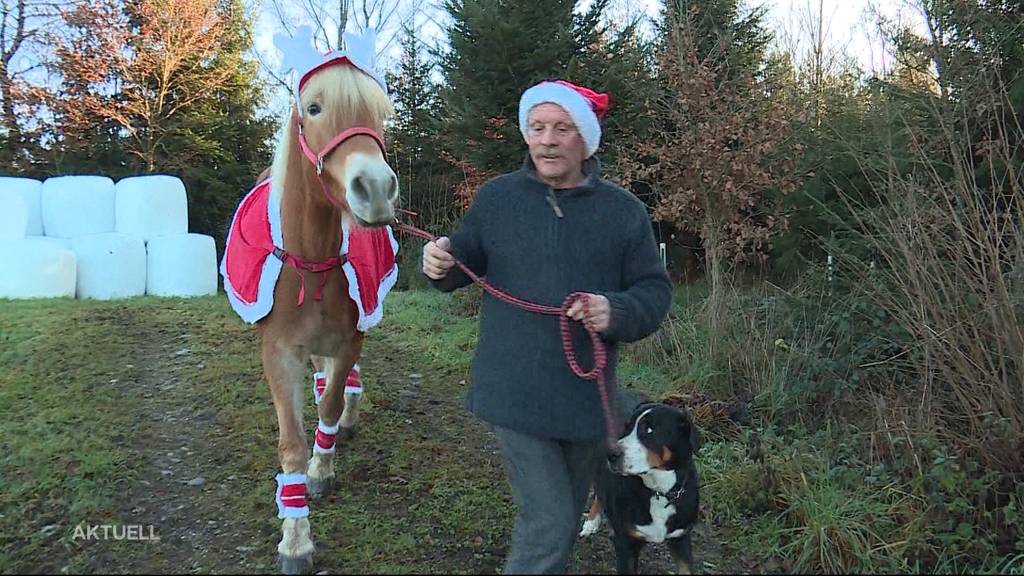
xmin=0 ymin=300 xmax=148 ymax=572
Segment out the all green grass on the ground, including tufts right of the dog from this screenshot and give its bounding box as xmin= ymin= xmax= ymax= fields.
xmin=0 ymin=288 xmax=1024 ymax=574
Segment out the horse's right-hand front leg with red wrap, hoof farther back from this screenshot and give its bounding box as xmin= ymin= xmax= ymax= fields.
xmin=306 ymin=341 xmax=361 ymax=498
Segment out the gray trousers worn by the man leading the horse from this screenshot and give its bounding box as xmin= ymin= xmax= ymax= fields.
xmin=495 ymin=426 xmax=604 ymax=574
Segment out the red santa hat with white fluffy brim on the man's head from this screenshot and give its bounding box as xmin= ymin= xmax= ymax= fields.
xmin=519 ymin=80 xmax=610 ymax=158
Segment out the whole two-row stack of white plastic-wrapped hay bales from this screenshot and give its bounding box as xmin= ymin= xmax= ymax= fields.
xmin=0 ymin=175 xmax=217 ymax=299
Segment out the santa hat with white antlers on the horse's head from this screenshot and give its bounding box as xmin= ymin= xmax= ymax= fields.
xmin=273 ymin=26 xmax=387 ymax=109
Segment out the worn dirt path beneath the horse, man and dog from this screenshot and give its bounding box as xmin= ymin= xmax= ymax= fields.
xmin=41 ymin=307 xmax=738 ymax=574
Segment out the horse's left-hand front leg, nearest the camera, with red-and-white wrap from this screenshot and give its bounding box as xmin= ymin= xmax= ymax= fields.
xmin=262 ymin=340 xmax=314 ymax=574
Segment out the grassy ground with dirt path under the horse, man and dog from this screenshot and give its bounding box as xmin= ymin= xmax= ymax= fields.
xmin=0 ymin=291 xmax=741 ymax=573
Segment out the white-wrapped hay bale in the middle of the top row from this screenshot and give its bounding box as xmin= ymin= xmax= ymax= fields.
xmin=42 ymin=176 xmax=114 ymax=238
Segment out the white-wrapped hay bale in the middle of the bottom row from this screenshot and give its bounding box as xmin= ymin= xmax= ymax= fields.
xmin=72 ymin=233 xmax=145 ymax=300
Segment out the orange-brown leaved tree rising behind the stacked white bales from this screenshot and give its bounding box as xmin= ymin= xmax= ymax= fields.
xmin=50 ymin=0 xmax=231 ymax=171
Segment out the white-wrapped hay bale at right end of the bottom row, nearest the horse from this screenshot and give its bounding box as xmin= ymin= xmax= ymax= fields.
xmin=145 ymin=234 xmax=217 ymax=296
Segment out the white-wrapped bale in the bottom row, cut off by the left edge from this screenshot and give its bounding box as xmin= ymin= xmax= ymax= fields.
xmin=0 ymin=239 xmax=77 ymax=298
